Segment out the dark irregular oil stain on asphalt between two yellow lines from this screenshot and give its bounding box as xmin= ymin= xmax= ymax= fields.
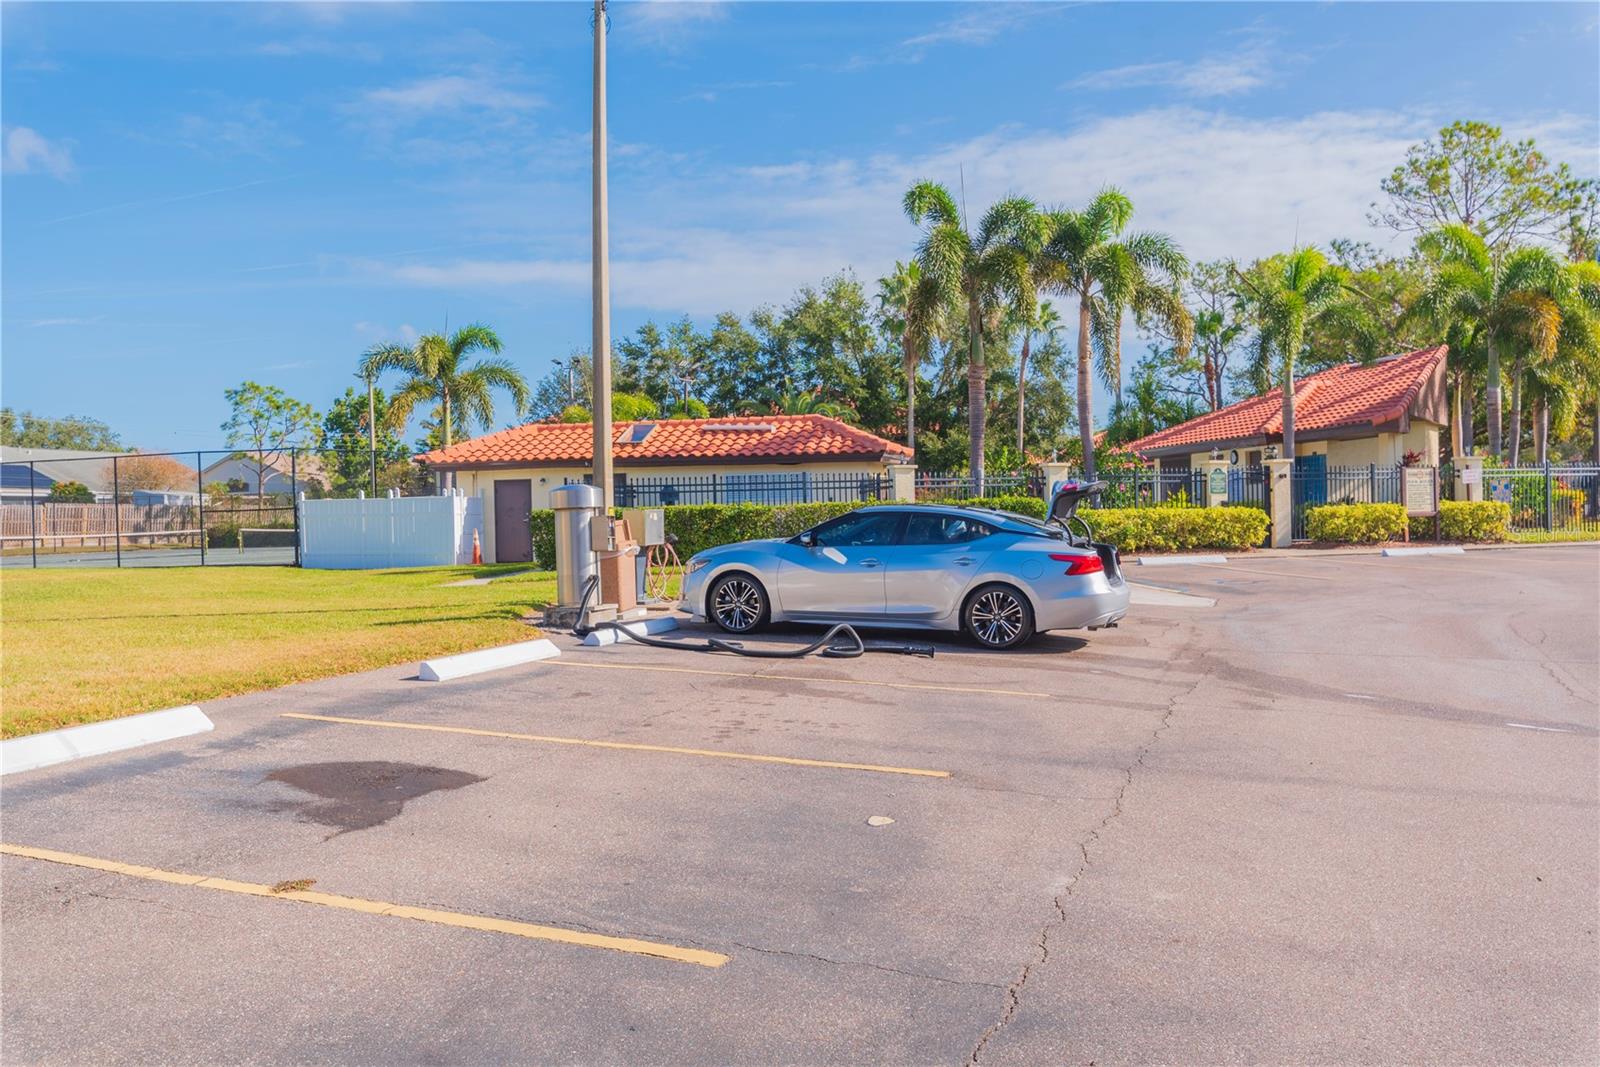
xmin=262 ymin=760 xmax=485 ymax=833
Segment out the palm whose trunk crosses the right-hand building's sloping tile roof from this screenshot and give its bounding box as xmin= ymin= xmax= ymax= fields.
xmin=1237 ymin=246 xmax=1354 ymax=459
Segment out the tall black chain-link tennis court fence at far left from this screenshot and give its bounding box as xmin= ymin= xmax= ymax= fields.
xmin=0 ymin=446 xmax=437 ymax=568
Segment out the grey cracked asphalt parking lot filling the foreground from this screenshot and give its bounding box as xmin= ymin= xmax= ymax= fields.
xmin=0 ymin=545 xmax=1600 ymax=1064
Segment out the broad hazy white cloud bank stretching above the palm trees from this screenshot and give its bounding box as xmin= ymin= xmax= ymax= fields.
xmin=360 ymin=107 xmax=1597 ymax=315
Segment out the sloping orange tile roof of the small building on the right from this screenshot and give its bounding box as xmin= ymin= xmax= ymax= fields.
xmin=1128 ymin=344 xmax=1450 ymax=453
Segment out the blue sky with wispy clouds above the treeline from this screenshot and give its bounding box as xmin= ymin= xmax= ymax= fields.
xmin=0 ymin=3 xmax=1600 ymax=450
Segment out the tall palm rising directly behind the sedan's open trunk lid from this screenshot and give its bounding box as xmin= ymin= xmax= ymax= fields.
xmin=1045 ymin=187 xmax=1194 ymax=480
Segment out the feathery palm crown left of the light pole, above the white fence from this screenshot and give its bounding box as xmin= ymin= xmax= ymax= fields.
xmin=360 ymin=325 xmax=531 ymax=448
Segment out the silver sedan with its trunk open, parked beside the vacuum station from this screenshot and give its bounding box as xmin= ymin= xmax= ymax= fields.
xmin=682 ymin=504 xmax=1128 ymax=648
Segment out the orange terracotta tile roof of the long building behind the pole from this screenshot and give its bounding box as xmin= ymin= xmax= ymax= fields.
xmin=418 ymin=414 xmax=910 ymax=467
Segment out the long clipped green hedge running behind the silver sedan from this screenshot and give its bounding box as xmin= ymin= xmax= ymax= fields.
xmin=531 ymin=496 xmax=1267 ymax=566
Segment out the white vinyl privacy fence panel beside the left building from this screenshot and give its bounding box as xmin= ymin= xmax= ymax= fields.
xmin=299 ymin=491 xmax=483 ymax=571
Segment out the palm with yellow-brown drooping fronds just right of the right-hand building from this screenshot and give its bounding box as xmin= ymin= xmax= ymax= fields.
xmin=1414 ymin=224 xmax=1563 ymax=456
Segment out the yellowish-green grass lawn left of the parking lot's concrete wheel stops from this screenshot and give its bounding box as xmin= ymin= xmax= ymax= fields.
xmin=0 ymin=565 xmax=555 ymax=737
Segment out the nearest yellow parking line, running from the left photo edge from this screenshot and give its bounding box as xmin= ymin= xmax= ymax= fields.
xmin=0 ymin=845 xmax=730 ymax=966
